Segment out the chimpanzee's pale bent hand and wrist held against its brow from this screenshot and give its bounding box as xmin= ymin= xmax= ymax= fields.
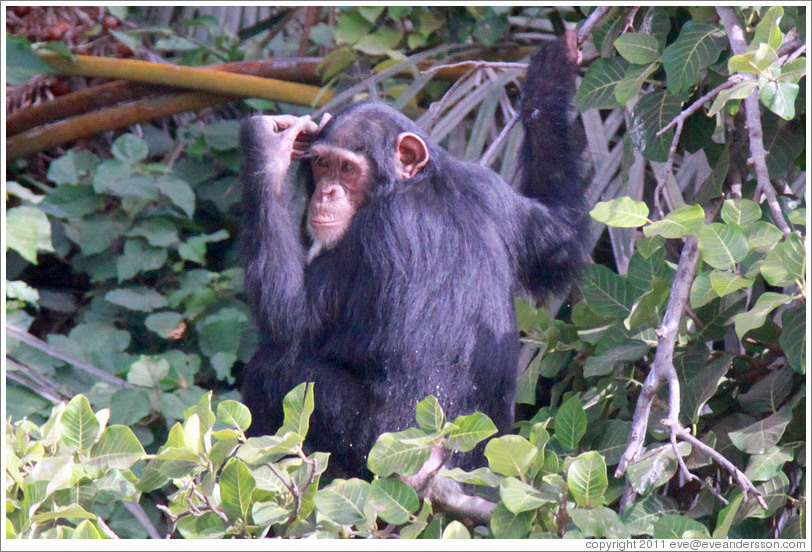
xmin=240 ymin=114 xmax=330 ymax=193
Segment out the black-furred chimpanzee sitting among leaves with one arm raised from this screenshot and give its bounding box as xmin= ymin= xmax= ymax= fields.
xmin=241 ymin=32 xmax=587 ymax=474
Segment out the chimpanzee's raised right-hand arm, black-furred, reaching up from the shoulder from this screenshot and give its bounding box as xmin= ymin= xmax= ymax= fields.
xmin=518 ymin=31 xmax=589 ymax=297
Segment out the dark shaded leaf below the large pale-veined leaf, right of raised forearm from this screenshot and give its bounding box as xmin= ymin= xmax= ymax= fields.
xmin=629 ymin=90 xmax=682 ymax=162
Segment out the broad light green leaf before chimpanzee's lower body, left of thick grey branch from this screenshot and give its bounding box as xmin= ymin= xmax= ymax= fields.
xmin=367 ymin=428 xmax=435 ymax=477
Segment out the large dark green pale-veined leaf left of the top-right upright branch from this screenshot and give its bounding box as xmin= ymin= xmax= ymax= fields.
xmin=663 ymin=21 xmax=725 ymax=94
